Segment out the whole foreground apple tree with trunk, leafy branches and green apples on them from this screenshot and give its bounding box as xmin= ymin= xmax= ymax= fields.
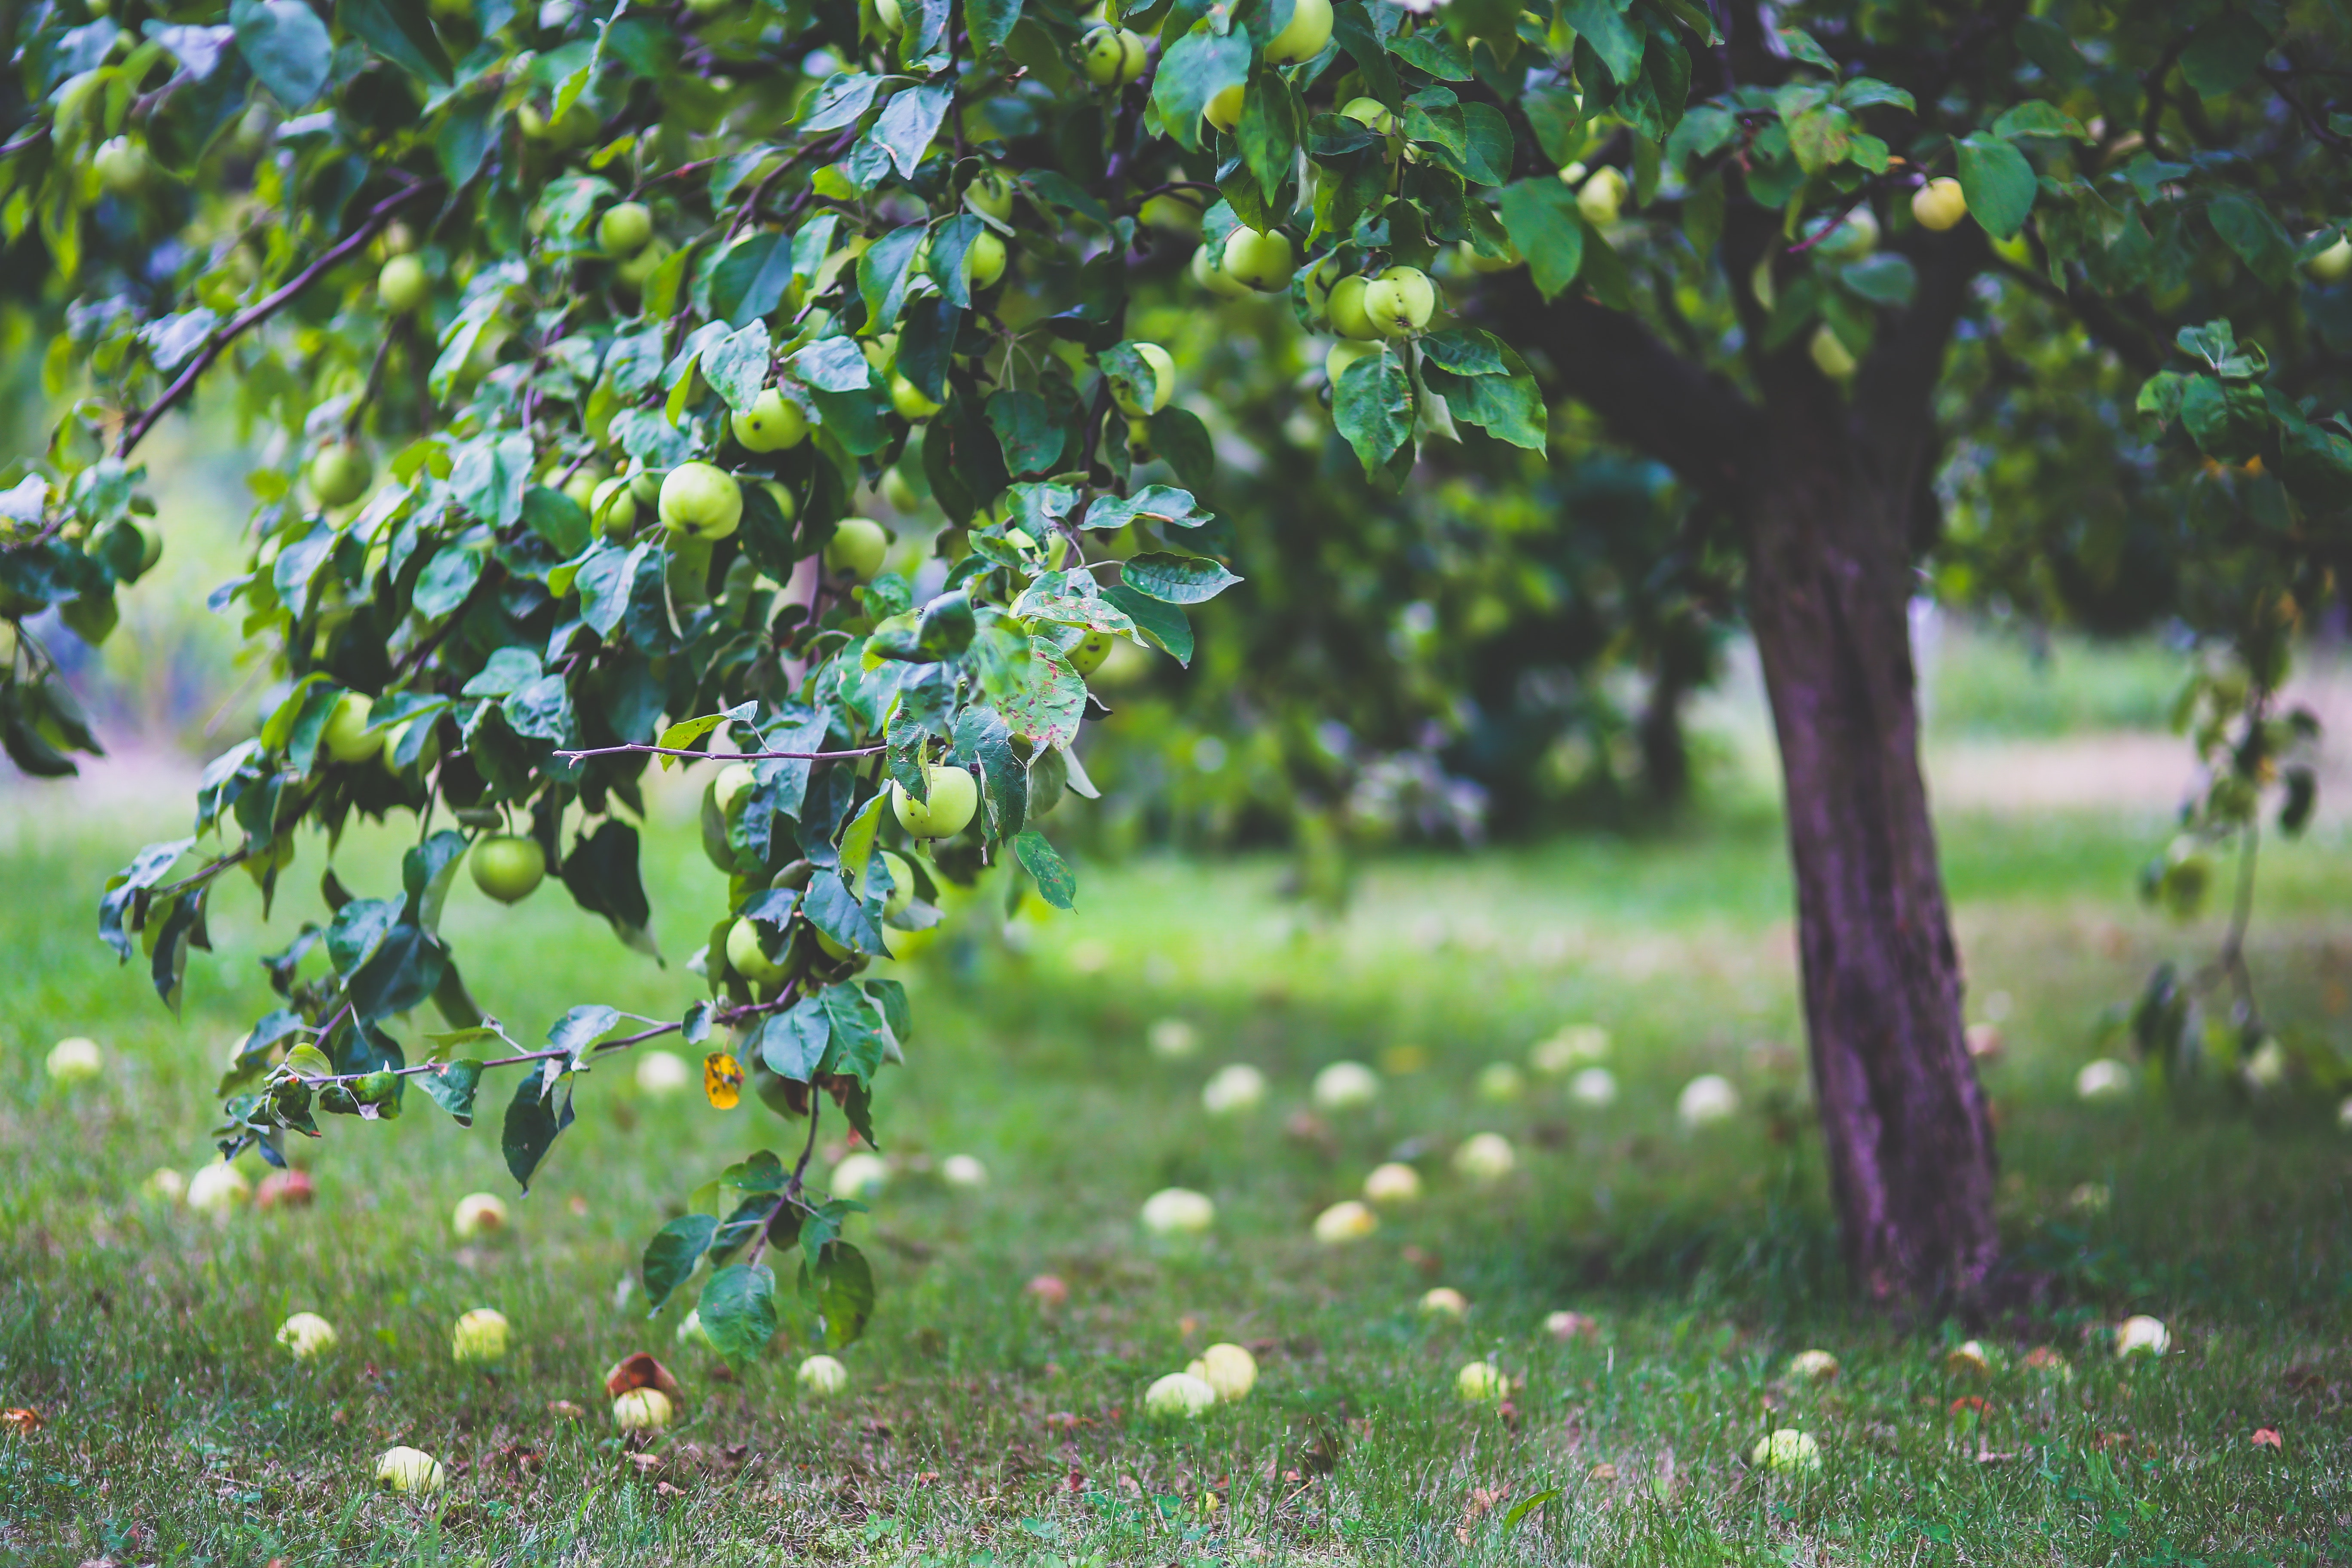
xmin=0 ymin=0 xmax=2352 ymax=1349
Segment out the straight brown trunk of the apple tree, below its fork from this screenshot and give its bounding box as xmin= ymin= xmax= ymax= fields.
xmin=1748 ymin=388 xmax=1999 ymax=1305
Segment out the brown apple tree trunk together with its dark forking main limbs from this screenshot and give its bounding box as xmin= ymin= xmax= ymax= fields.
xmin=1489 ymin=237 xmax=1999 ymax=1307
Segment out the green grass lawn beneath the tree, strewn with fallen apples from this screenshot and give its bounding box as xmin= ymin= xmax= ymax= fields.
xmin=0 ymin=797 xmax=2352 ymax=1568
